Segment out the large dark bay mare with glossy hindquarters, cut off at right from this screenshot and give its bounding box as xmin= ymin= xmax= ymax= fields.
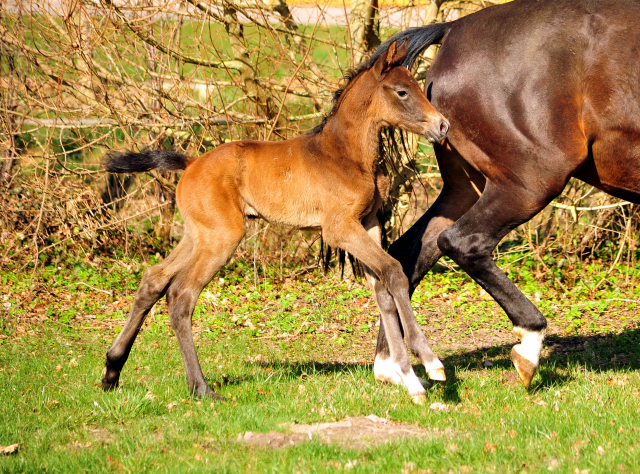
xmin=371 ymin=0 xmax=640 ymax=388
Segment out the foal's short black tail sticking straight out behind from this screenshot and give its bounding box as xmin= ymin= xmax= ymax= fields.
xmin=102 ymin=150 xmax=189 ymax=173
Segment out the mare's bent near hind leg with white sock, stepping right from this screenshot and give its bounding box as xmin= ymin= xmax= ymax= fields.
xmin=438 ymin=176 xmax=566 ymax=388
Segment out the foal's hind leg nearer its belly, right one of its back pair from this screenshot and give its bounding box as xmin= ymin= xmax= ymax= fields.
xmin=167 ymin=224 xmax=245 ymax=398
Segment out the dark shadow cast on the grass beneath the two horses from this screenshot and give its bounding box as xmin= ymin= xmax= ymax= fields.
xmin=238 ymin=328 xmax=640 ymax=404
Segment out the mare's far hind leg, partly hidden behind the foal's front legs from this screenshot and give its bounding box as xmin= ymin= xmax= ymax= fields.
xmin=373 ymin=142 xmax=485 ymax=380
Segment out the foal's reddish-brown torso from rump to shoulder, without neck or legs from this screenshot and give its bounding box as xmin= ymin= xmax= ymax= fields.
xmin=177 ymin=133 xmax=375 ymax=228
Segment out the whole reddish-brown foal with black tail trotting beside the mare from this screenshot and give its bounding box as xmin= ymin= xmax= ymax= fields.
xmin=102 ymin=44 xmax=449 ymax=403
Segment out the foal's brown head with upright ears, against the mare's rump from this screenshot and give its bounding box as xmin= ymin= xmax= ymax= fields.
xmin=369 ymin=42 xmax=449 ymax=142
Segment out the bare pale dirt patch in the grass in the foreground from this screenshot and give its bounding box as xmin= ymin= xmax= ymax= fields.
xmin=237 ymin=415 xmax=453 ymax=449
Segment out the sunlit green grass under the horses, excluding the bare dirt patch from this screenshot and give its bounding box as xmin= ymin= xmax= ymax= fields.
xmin=0 ymin=257 xmax=640 ymax=473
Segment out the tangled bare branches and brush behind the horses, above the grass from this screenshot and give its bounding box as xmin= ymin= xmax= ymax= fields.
xmin=0 ymin=0 xmax=637 ymax=284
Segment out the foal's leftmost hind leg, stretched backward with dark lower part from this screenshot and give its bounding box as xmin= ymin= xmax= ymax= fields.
xmin=102 ymin=236 xmax=193 ymax=390
